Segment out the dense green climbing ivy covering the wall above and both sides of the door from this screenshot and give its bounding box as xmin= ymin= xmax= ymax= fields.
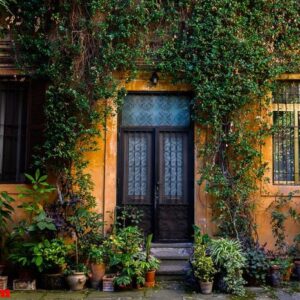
xmin=2 ymin=0 xmax=300 ymax=239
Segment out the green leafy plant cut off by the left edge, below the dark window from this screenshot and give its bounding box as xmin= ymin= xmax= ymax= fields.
xmin=0 ymin=192 xmax=15 ymax=262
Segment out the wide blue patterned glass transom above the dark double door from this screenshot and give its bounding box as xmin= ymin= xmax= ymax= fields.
xmin=122 ymin=95 xmax=190 ymax=127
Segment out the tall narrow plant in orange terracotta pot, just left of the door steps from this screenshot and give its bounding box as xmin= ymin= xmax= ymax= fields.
xmin=145 ymin=234 xmax=160 ymax=287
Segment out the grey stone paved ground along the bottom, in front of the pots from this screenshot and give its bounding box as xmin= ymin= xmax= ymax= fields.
xmin=10 ymin=282 xmax=300 ymax=300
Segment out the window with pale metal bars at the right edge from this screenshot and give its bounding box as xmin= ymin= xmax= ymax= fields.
xmin=273 ymin=81 xmax=300 ymax=184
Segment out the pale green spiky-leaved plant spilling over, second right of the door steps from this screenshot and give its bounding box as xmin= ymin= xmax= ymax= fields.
xmin=210 ymin=238 xmax=246 ymax=296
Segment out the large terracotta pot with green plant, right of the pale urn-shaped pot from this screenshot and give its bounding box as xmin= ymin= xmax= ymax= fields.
xmin=89 ymin=245 xmax=106 ymax=289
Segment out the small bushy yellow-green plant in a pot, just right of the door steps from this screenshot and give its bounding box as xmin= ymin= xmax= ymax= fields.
xmin=192 ymin=240 xmax=216 ymax=294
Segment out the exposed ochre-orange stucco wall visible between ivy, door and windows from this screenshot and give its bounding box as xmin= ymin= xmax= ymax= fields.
xmin=0 ymin=73 xmax=300 ymax=248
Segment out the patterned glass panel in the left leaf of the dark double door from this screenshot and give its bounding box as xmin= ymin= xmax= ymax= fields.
xmin=128 ymin=132 xmax=148 ymax=196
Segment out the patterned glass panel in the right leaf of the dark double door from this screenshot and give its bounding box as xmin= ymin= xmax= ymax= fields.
xmin=163 ymin=133 xmax=183 ymax=197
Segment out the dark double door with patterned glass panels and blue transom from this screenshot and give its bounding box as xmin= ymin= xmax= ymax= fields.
xmin=118 ymin=94 xmax=193 ymax=241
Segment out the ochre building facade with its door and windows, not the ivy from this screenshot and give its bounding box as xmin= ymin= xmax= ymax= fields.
xmin=0 ymin=37 xmax=300 ymax=248
